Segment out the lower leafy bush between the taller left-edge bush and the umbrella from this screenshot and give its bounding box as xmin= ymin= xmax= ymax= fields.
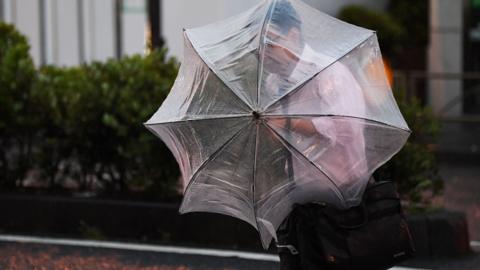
xmin=33 ymin=50 xmax=178 ymax=198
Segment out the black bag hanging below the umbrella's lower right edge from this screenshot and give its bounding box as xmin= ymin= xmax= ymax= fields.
xmin=277 ymin=181 xmax=415 ymax=270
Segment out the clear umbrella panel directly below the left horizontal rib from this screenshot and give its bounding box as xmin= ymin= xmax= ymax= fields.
xmin=147 ymin=117 xmax=251 ymax=188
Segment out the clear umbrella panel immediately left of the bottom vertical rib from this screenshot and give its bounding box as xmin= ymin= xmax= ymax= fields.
xmin=180 ymin=124 xmax=257 ymax=228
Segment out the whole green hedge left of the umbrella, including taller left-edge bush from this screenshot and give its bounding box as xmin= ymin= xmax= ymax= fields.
xmin=0 ymin=24 xmax=179 ymax=199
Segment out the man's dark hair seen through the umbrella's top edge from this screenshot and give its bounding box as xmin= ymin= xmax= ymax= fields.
xmin=272 ymin=0 xmax=302 ymax=34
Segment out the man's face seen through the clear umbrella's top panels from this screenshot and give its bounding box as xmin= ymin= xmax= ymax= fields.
xmin=263 ymin=28 xmax=301 ymax=76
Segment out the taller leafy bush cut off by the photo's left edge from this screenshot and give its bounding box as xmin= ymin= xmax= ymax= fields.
xmin=0 ymin=23 xmax=38 ymax=188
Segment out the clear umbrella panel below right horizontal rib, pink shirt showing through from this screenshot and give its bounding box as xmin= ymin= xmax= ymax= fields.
xmin=267 ymin=116 xmax=410 ymax=204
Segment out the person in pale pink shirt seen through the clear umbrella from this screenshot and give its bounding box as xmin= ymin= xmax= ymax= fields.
xmin=263 ymin=1 xmax=367 ymax=204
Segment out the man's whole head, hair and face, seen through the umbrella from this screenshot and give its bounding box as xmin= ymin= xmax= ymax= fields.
xmin=264 ymin=0 xmax=304 ymax=76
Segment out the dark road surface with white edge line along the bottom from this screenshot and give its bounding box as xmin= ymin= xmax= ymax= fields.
xmin=0 ymin=235 xmax=480 ymax=270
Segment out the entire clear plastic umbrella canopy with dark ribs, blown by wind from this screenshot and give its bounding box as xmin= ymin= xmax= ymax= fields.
xmin=146 ymin=0 xmax=410 ymax=248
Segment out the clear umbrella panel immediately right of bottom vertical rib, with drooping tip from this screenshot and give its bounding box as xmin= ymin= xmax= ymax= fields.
xmin=255 ymin=124 xmax=345 ymax=248
